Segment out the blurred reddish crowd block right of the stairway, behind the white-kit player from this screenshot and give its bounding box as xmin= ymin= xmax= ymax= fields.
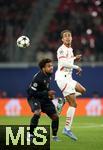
xmin=36 ymin=0 xmax=103 ymax=62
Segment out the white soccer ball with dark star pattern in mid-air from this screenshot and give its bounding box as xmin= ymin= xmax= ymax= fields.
xmin=17 ymin=36 xmax=30 ymax=48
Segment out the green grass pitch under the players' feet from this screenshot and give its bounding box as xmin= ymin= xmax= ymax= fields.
xmin=0 ymin=116 xmax=103 ymax=150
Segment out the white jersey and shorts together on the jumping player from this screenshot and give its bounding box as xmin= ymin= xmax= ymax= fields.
xmin=55 ymin=44 xmax=77 ymax=96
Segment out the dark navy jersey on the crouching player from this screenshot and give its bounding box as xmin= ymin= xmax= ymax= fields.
xmin=27 ymin=71 xmax=51 ymax=99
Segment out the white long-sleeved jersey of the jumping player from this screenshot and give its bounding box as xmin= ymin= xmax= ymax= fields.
xmin=55 ymin=44 xmax=75 ymax=80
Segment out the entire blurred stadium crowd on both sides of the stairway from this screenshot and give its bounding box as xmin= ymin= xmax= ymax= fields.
xmin=0 ymin=0 xmax=103 ymax=62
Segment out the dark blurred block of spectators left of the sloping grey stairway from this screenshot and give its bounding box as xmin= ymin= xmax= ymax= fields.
xmin=0 ymin=0 xmax=36 ymax=62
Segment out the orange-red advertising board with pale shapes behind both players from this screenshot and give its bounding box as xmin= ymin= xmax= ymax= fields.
xmin=0 ymin=98 xmax=103 ymax=116
